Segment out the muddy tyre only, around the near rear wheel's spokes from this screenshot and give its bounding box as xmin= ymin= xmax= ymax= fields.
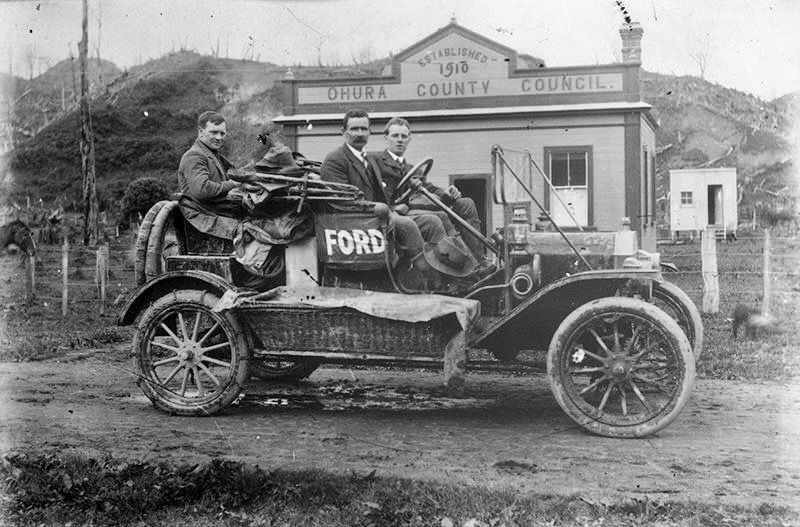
xmin=133 ymin=289 xmax=250 ymax=416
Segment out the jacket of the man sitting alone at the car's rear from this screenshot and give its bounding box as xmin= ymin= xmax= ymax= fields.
xmin=178 ymin=139 xmax=236 ymax=205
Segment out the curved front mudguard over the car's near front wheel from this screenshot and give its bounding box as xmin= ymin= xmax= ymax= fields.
xmin=470 ymin=269 xmax=662 ymax=349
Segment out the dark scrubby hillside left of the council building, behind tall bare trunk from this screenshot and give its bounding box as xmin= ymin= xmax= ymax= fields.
xmin=4 ymin=52 xmax=284 ymax=208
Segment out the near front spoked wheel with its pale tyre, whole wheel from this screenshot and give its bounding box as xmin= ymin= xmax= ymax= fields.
xmin=547 ymin=297 xmax=695 ymax=437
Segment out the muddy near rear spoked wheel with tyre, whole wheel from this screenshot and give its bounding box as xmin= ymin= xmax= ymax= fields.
xmin=134 ymin=289 xmax=249 ymax=416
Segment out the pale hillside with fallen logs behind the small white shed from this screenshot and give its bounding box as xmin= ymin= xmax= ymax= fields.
xmin=642 ymin=72 xmax=799 ymax=219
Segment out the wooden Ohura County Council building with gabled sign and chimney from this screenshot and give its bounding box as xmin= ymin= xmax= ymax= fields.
xmin=274 ymin=20 xmax=657 ymax=239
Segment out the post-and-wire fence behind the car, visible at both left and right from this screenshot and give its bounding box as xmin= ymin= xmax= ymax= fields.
xmin=0 ymin=226 xmax=800 ymax=316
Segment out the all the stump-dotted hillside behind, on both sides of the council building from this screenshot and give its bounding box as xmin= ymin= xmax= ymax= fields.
xmin=3 ymin=56 xmax=800 ymax=225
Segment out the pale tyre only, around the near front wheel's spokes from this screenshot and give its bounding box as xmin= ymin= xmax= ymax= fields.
xmin=547 ymin=297 xmax=695 ymax=438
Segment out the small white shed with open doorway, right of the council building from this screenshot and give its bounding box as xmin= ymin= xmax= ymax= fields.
xmin=669 ymin=168 xmax=738 ymax=237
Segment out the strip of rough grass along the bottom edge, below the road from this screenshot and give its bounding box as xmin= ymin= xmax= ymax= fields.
xmin=0 ymin=453 xmax=800 ymax=527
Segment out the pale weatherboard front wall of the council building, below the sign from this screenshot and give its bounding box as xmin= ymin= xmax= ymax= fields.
xmin=296 ymin=116 xmax=625 ymax=230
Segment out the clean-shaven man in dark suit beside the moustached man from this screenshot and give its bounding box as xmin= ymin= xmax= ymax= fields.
xmin=370 ymin=117 xmax=484 ymax=262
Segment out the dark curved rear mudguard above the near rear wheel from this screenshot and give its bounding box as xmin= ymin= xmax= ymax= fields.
xmin=117 ymin=271 xmax=236 ymax=326
